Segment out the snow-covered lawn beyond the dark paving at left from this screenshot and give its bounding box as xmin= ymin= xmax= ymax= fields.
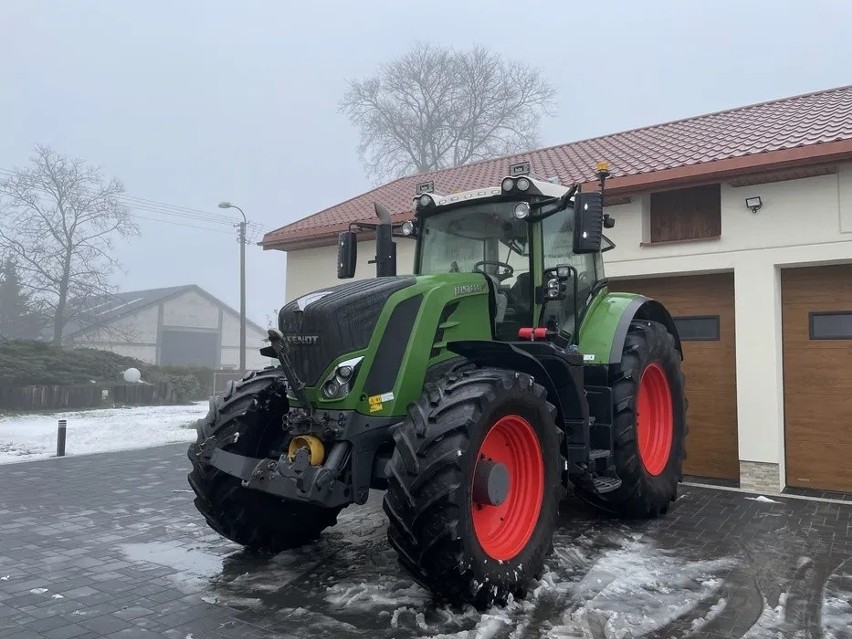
xmin=0 ymin=401 xmax=208 ymax=464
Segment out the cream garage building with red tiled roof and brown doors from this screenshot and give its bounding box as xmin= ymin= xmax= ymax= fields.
xmin=262 ymin=86 xmax=852 ymax=492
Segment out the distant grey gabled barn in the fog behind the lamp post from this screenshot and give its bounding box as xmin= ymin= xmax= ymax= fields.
xmin=64 ymin=284 xmax=269 ymax=370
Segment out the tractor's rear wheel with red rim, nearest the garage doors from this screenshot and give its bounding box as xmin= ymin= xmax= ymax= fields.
xmin=593 ymin=320 xmax=687 ymax=518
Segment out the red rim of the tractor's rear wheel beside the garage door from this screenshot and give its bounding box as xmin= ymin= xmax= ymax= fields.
xmin=636 ymin=364 xmax=674 ymax=475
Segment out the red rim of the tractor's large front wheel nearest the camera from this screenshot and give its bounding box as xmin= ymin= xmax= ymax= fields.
xmin=471 ymin=415 xmax=544 ymax=561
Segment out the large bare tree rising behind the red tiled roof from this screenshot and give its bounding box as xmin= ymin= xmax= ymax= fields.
xmin=340 ymin=43 xmax=556 ymax=181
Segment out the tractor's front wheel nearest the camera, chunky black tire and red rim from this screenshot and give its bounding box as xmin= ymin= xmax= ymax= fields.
xmin=384 ymin=368 xmax=561 ymax=608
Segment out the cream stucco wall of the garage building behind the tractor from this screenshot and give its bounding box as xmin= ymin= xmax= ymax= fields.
xmin=286 ymin=163 xmax=852 ymax=490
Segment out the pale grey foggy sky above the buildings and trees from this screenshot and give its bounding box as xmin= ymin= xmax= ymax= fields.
xmin=0 ymin=0 xmax=852 ymax=326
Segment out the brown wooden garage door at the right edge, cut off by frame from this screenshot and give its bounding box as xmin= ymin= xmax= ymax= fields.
xmin=781 ymin=265 xmax=852 ymax=492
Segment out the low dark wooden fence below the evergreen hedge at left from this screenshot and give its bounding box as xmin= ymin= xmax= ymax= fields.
xmin=0 ymin=382 xmax=175 ymax=410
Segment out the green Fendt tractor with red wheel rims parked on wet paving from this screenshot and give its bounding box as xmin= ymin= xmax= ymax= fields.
xmin=188 ymin=163 xmax=686 ymax=608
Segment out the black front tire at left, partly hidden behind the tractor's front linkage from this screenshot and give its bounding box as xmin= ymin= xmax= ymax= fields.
xmin=187 ymin=368 xmax=341 ymax=554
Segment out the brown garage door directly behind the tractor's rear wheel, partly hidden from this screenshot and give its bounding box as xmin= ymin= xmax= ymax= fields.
xmin=610 ymin=273 xmax=740 ymax=480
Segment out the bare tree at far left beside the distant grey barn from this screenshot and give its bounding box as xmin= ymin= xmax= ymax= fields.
xmin=0 ymin=146 xmax=139 ymax=345
